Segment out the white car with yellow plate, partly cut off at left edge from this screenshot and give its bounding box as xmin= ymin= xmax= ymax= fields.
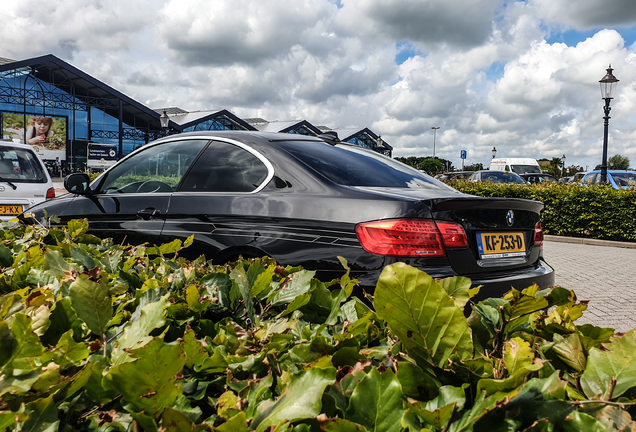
xmin=0 ymin=141 xmax=55 ymax=221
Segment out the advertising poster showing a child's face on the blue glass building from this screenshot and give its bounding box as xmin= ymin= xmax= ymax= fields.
xmin=2 ymin=113 xmax=68 ymax=160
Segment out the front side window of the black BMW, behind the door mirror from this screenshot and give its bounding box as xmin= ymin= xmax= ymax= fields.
xmin=98 ymin=140 xmax=208 ymax=194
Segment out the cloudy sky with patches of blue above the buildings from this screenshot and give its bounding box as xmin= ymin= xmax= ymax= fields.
xmin=0 ymin=0 xmax=636 ymax=169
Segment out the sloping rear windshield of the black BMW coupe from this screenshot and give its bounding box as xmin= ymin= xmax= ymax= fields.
xmin=279 ymin=141 xmax=449 ymax=189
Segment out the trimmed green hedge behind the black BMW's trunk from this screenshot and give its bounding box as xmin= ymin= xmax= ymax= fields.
xmin=452 ymin=181 xmax=636 ymax=242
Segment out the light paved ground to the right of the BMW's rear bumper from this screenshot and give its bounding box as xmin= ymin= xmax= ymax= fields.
xmin=544 ymin=241 xmax=636 ymax=331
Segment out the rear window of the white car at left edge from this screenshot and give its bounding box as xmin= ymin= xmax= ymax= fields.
xmin=0 ymin=146 xmax=47 ymax=183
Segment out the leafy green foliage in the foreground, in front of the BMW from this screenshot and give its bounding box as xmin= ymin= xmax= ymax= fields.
xmin=0 ymin=221 xmax=636 ymax=432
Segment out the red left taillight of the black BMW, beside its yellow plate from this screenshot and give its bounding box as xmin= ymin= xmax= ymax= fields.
xmin=356 ymin=219 xmax=468 ymax=257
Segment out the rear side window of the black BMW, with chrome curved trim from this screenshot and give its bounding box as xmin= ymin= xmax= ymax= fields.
xmin=179 ymin=141 xmax=268 ymax=192
